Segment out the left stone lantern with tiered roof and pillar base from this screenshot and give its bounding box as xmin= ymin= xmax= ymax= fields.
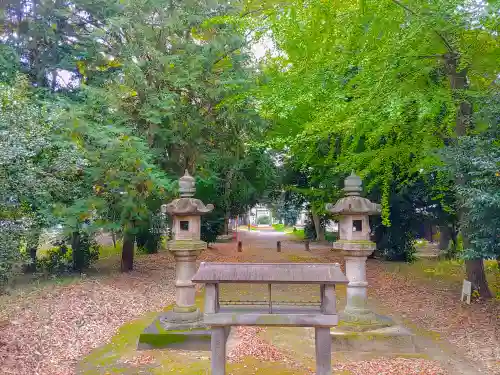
xmin=161 ymin=170 xmax=214 ymax=329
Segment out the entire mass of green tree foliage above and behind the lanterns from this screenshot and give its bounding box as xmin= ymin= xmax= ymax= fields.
xmin=0 ymin=0 xmax=500 ymax=297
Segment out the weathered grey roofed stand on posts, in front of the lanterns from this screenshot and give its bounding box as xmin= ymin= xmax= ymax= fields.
xmin=193 ymin=263 xmax=347 ymax=375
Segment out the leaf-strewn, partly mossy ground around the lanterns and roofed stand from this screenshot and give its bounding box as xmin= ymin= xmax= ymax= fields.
xmin=0 ymin=232 xmax=500 ymax=375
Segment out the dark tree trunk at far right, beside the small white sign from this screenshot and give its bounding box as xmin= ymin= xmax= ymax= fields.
xmin=444 ymin=52 xmax=493 ymax=298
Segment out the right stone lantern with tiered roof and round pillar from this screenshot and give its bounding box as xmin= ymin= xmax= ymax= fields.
xmin=326 ymin=172 xmax=388 ymax=328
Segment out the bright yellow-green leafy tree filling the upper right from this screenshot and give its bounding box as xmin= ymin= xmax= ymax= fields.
xmin=256 ymin=0 xmax=500 ymax=297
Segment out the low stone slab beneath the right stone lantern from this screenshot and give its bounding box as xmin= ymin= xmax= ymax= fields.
xmin=330 ymin=326 xmax=417 ymax=354
